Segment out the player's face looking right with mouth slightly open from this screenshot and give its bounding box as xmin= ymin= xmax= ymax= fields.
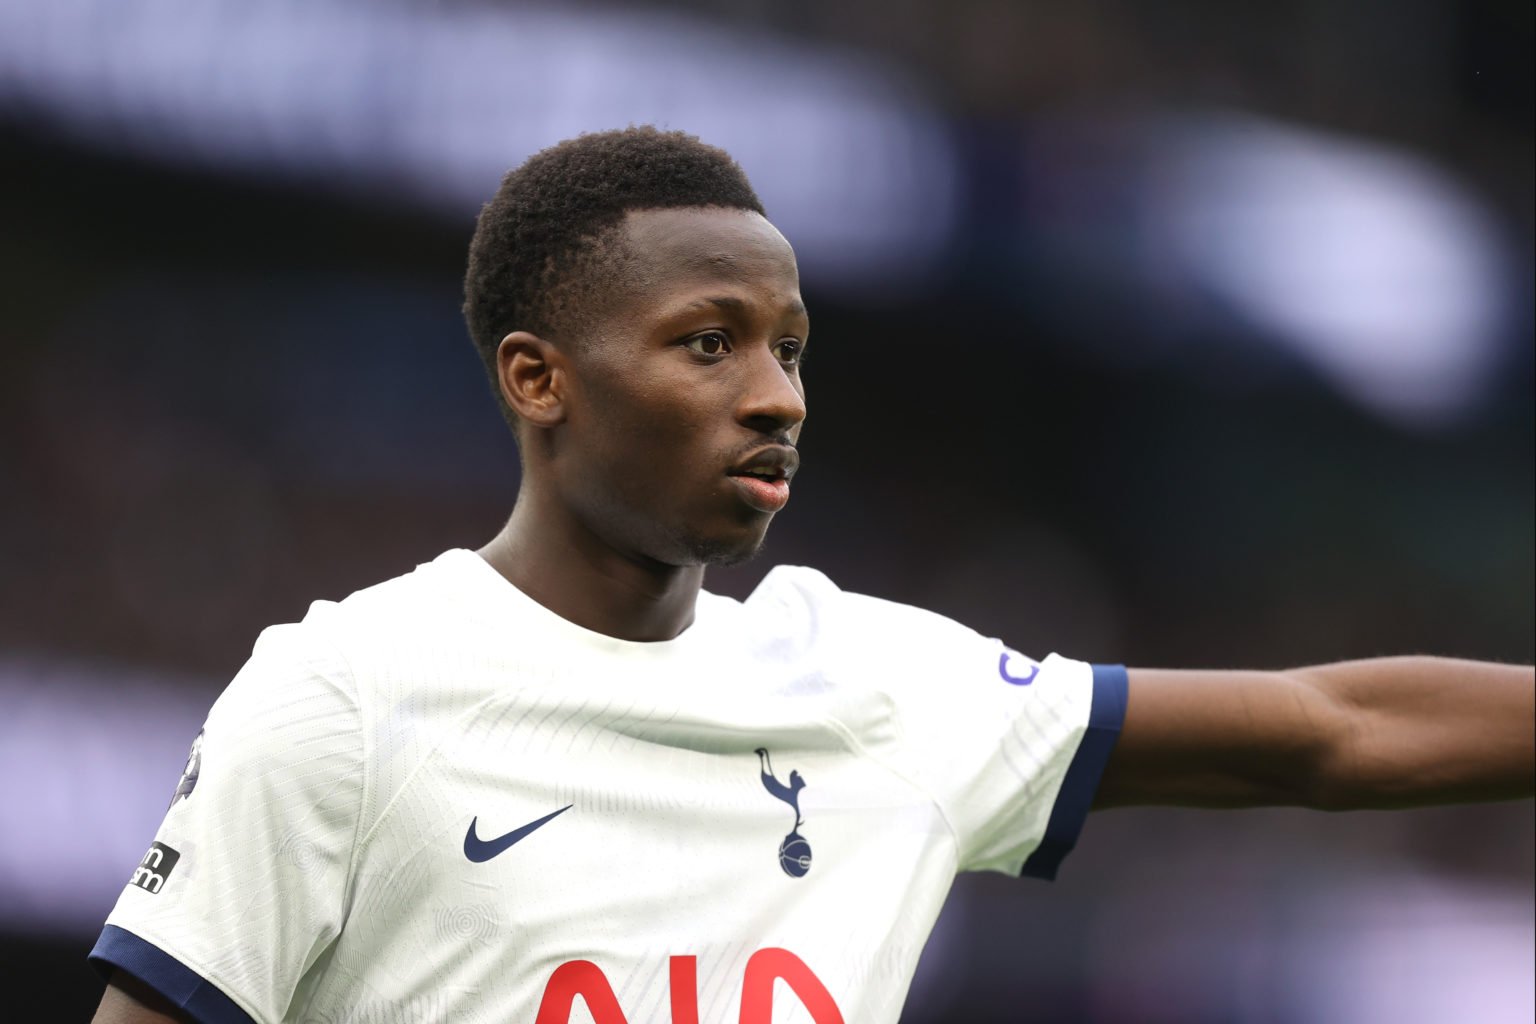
xmin=553 ymin=207 xmax=809 ymax=565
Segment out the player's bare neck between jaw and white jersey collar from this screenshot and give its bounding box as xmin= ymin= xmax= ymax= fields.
xmin=479 ymin=496 xmax=703 ymax=642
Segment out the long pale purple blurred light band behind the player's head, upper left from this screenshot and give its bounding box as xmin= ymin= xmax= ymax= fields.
xmin=0 ymin=0 xmax=955 ymax=293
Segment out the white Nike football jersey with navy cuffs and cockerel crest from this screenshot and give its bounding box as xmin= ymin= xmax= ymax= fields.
xmin=92 ymin=550 xmax=1124 ymax=1024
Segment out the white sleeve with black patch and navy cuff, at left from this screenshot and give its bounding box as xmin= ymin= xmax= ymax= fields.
xmin=91 ymin=626 xmax=364 ymax=1022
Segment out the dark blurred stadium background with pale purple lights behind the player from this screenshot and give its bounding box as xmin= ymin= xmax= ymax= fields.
xmin=0 ymin=0 xmax=1536 ymax=1024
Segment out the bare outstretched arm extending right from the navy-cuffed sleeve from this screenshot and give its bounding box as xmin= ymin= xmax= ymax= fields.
xmin=1094 ymin=657 xmax=1536 ymax=811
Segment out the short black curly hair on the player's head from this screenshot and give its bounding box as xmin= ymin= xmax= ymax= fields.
xmin=464 ymin=124 xmax=763 ymax=425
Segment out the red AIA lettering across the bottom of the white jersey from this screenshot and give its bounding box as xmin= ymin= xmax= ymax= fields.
xmin=535 ymin=947 xmax=843 ymax=1024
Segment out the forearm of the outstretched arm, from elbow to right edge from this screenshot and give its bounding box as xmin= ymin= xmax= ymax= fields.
xmin=1293 ymin=657 xmax=1536 ymax=809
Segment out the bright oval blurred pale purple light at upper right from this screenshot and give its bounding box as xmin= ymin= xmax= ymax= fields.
xmin=1149 ymin=115 xmax=1513 ymax=422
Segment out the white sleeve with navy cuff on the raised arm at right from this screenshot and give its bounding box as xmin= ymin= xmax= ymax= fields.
xmin=804 ymin=582 xmax=1126 ymax=878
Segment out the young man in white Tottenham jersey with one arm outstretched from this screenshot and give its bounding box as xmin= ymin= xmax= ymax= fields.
xmin=92 ymin=129 xmax=1536 ymax=1024
